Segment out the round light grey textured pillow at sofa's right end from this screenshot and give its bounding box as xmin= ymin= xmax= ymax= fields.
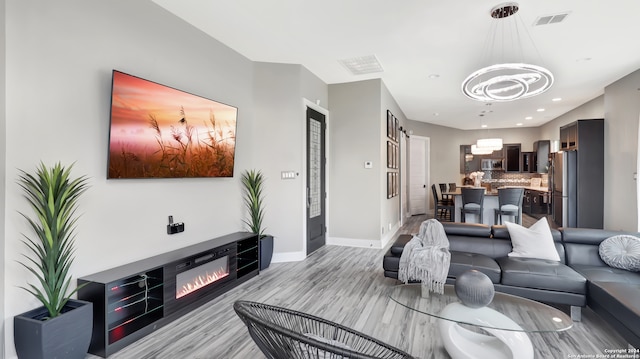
xmin=598 ymin=234 xmax=640 ymax=272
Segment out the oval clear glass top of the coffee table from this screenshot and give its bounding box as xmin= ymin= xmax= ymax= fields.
xmin=389 ymin=284 xmax=573 ymax=333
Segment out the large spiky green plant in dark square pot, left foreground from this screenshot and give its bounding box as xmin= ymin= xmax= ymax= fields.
xmin=14 ymin=163 xmax=93 ymax=359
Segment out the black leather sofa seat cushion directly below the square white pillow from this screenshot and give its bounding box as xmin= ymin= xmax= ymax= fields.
xmin=497 ymin=257 xmax=587 ymax=294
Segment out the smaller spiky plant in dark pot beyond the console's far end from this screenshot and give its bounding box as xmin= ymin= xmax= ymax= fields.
xmin=242 ymin=170 xmax=273 ymax=270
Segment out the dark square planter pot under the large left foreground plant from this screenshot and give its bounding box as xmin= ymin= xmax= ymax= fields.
xmin=13 ymin=299 xmax=93 ymax=359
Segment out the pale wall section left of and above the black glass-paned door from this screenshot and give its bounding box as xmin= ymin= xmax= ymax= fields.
xmin=252 ymin=62 xmax=328 ymax=262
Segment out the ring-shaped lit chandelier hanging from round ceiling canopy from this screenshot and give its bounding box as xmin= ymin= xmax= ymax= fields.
xmin=462 ymin=3 xmax=553 ymax=102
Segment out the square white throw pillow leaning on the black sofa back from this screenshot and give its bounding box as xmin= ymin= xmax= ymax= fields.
xmin=505 ymin=218 xmax=560 ymax=262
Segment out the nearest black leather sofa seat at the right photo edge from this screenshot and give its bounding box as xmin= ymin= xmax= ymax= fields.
xmin=588 ymin=281 xmax=640 ymax=336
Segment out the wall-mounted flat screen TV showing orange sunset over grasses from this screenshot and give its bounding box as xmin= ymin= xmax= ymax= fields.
xmin=107 ymin=70 xmax=238 ymax=178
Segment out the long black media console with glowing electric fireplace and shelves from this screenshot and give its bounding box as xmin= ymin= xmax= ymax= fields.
xmin=78 ymin=232 xmax=259 ymax=358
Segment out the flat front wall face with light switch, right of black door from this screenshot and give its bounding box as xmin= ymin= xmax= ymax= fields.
xmin=328 ymin=80 xmax=386 ymax=246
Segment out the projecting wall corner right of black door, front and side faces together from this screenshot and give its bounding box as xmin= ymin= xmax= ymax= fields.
xmin=329 ymin=79 xmax=406 ymax=248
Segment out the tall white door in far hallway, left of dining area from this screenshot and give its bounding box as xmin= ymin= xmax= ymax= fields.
xmin=408 ymin=135 xmax=430 ymax=216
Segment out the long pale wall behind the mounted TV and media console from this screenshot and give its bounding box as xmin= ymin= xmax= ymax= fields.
xmin=0 ymin=0 xmax=258 ymax=357
